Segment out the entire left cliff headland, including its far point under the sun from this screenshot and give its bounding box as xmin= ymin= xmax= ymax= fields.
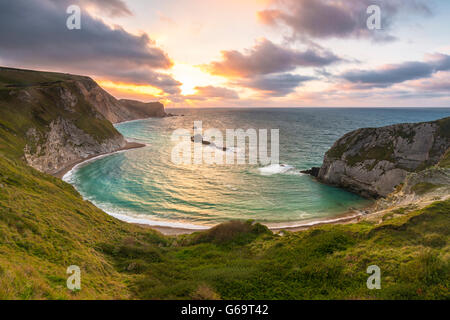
xmin=0 ymin=68 xmax=165 ymax=174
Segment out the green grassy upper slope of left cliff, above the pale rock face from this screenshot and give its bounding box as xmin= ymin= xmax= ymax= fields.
xmin=0 ymin=68 xmax=120 ymax=158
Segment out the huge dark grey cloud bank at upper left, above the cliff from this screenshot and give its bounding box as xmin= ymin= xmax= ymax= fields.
xmin=0 ymin=0 xmax=179 ymax=92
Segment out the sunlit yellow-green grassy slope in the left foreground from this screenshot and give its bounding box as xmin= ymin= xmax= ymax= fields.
xmin=0 ymin=157 xmax=166 ymax=299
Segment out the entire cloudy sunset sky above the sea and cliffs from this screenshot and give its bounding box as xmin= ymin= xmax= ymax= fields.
xmin=0 ymin=0 xmax=450 ymax=108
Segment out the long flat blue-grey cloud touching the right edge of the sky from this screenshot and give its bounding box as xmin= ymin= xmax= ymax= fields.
xmin=340 ymin=54 xmax=450 ymax=88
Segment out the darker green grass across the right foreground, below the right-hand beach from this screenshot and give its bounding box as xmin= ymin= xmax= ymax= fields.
xmin=122 ymin=202 xmax=450 ymax=299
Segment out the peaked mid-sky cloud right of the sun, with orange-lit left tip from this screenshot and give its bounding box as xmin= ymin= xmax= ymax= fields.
xmin=201 ymin=39 xmax=341 ymax=78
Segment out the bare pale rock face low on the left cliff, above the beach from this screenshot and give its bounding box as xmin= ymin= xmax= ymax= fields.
xmin=24 ymin=118 xmax=126 ymax=174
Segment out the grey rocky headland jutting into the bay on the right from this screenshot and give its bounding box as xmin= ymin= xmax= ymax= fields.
xmin=318 ymin=118 xmax=450 ymax=198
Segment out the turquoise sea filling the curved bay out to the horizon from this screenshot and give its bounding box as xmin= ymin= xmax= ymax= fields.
xmin=65 ymin=109 xmax=450 ymax=227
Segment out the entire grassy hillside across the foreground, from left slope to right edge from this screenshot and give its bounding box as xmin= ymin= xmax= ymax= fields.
xmin=0 ymin=152 xmax=450 ymax=299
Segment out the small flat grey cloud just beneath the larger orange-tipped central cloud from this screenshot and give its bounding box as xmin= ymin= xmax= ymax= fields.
xmin=237 ymin=73 xmax=314 ymax=97
